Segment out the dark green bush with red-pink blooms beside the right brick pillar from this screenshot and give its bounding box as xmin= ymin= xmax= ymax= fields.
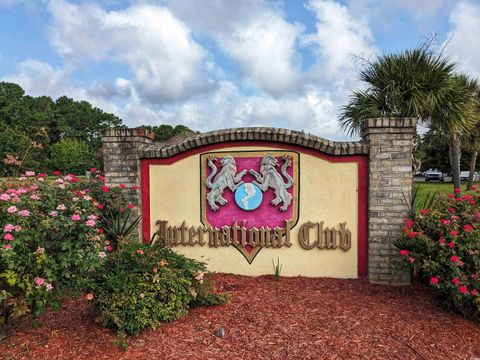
xmin=396 ymin=188 xmax=480 ymax=319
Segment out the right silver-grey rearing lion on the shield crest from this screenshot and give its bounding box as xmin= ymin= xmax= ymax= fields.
xmin=250 ymin=154 xmax=293 ymax=211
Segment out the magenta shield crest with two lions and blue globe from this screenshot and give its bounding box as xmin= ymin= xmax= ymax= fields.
xmin=200 ymin=150 xmax=300 ymax=264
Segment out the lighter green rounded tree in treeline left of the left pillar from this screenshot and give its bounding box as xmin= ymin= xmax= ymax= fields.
xmin=50 ymin=139 xmax=99 ymax=174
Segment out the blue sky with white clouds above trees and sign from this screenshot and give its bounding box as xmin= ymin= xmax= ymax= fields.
xmin=0 ymin=0 xmax=480 ymax=140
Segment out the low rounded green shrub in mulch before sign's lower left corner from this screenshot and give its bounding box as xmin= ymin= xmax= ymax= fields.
xmin=87 ymin=243 xmax=225 ymax=337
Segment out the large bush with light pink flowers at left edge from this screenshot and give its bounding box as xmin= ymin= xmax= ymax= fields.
xmin=0 ymin=169 xmax=135 ymax=324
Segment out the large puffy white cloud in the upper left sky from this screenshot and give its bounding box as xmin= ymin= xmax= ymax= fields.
xmin=49 ymin=0 xmax=211 ymax=102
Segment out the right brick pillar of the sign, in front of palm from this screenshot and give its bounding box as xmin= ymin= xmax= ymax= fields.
xmin=362 ymin=118 xmax=416 ymax=285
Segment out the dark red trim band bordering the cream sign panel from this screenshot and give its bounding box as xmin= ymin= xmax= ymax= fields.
xmin=140 ymin=141 xmax=368 ymax=278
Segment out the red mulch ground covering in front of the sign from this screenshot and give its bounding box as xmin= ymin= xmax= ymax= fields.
xmin=0 ymin=274 xmax=480 ymax=360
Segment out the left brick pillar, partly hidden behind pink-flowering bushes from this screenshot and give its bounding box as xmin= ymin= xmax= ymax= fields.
xmin=101 ymin=129 xmax=155 ymax=238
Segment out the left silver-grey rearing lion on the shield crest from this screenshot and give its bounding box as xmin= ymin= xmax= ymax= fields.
xmin=206 ymin=155 xmax=247 ymax=211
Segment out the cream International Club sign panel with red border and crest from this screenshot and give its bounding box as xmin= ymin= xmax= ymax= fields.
xmin=141 ymin=142 xmax=367 ymax=278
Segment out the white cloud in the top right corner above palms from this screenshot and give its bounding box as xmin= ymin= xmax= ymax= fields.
xmin=446 ymin=1 xmax=480 ymax=77
